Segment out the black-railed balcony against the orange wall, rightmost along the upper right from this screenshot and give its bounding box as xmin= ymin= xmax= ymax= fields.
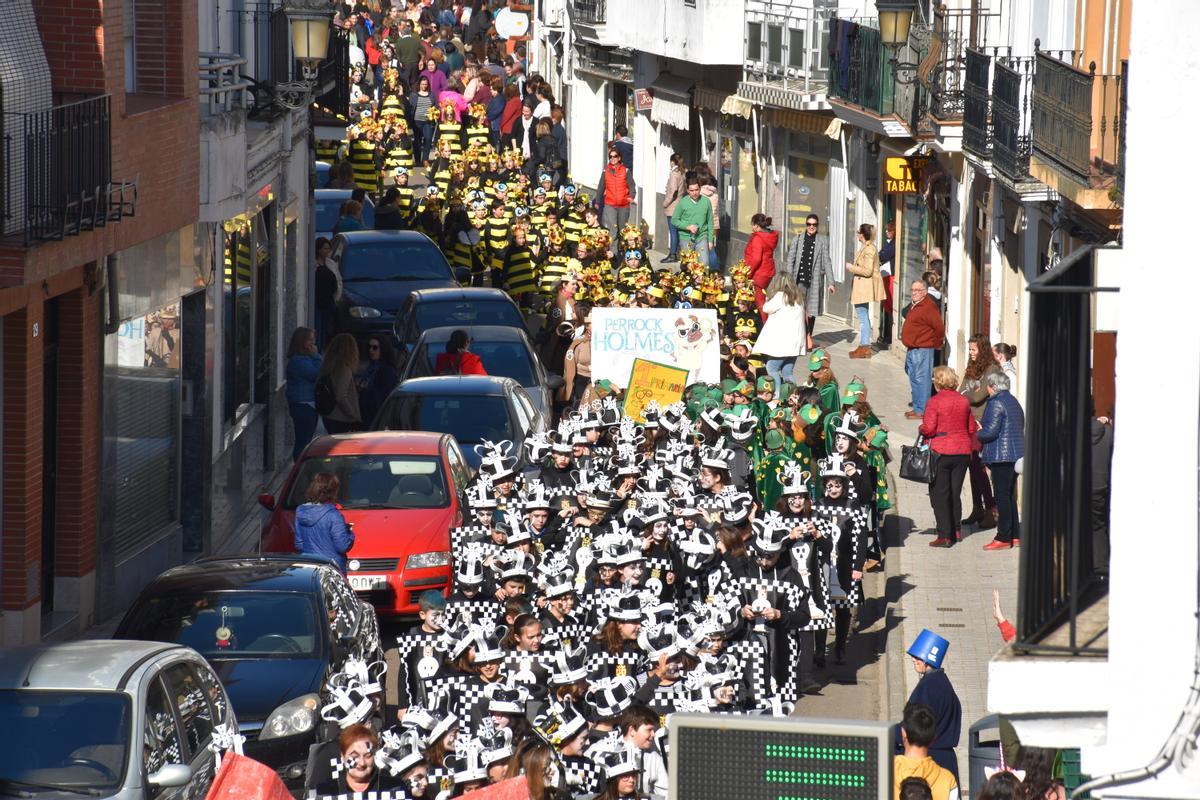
xmin=1031 ymin=53 xmax=1127 ymax=209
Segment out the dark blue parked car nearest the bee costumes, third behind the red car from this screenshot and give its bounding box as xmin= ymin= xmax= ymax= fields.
xmin=330 ymin=230 xmax=458 ymax=341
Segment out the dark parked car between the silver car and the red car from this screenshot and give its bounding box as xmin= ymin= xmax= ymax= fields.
xmin=113 ymin=555 xmax=383 ymax=783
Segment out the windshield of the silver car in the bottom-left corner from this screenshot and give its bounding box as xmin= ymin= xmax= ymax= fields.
xmin=0 ymin=688 xmax=131 ymax=793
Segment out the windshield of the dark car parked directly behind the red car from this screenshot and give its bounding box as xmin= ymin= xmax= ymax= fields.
xmin=382 ymin=395 xmax=512 ymax=445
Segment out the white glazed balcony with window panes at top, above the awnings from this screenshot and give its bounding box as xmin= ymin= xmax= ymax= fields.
xmin=738 ymin=0 xmax=829 ymax=112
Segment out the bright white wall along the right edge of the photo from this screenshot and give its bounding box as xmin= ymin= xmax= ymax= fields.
xmin=1084 ymin=0 xmax=1200 ymax=798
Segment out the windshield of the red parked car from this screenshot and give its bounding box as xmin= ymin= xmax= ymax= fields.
xmin=283 ymin=455 xmax=449 ymax=511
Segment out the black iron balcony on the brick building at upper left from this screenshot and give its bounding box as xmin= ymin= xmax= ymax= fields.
xmin=0 ymin=95 xmax=137 ymax=246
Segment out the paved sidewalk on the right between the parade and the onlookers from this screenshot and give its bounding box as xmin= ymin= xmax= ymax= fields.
xmin=816 ymin=318 xmax=1019 ymax=794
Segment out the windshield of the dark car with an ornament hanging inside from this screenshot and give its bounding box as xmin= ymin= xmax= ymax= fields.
xmin=121 ymin=588 xmax=320 ymax=658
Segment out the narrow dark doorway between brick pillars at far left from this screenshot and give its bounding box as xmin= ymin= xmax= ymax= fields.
xmin=42 ymin=297 xmax=59 ymax=630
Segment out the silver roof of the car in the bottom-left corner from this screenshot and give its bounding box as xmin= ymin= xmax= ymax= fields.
xmin=0 ymin=639 xmax=186 ymax=691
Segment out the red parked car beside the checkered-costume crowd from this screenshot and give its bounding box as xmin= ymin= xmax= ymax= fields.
xmin=258 ymin=432 xmax=470 ymax=616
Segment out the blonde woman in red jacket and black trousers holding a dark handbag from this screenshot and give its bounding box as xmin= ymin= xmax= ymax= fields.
xmin=920 ymin=367 xmax=979 ymax=547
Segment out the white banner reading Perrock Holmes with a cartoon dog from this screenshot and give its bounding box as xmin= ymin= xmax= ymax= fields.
xmin=592 ymin=308 xmax=721 ymax=389
